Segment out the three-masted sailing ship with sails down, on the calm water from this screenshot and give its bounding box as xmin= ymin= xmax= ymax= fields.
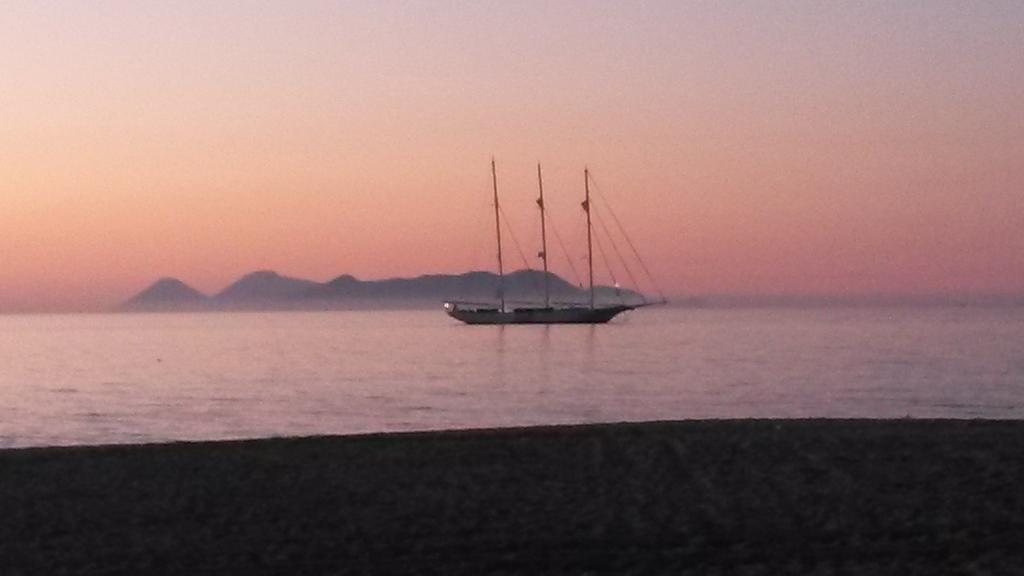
xmin=444 ymin=159 xmax=649 ymax=324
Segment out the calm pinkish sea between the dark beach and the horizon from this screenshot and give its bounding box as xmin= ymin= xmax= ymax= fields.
xmin=0 ymin=307 xmax=1024 ymax=447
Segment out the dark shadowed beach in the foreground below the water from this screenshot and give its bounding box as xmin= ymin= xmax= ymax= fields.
xmin=0 ymin=420 xmax=1024 ymax=575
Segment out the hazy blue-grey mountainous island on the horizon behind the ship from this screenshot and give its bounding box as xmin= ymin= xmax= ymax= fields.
xmin=118 ymin=270 xmax=642 ymax=312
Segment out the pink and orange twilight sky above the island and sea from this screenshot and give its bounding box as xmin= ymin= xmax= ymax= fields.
xmin=0 ymin=0 xmax=1024 ymax=312
